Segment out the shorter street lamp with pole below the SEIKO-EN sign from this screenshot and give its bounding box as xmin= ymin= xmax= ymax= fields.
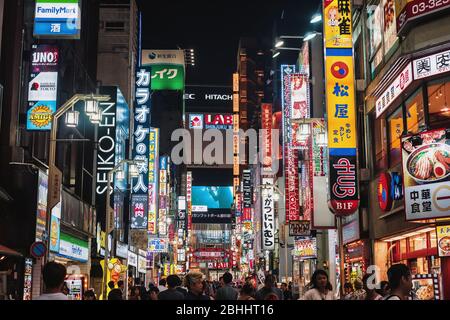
xmin=102 ymin=159 xmax=139 ymax=300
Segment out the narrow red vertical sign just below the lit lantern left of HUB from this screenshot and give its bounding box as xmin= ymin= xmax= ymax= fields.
xmin=285 ymin=147 xmax=300 ymax=222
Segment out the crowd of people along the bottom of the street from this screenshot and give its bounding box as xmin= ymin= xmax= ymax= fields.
xmin=38 ymin=262 xmax=414 ymax=300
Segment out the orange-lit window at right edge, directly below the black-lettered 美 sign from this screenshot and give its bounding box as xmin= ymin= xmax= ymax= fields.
xmin=428 ymin=79 xmax=450 ymax=128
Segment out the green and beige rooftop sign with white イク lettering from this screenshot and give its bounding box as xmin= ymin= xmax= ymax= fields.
xmin=141 ymin=50 xmax=185 ymax=91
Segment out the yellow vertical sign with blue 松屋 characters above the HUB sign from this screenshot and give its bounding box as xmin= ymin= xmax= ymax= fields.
xmin=326 ymin=55 xmax=357 ymax=148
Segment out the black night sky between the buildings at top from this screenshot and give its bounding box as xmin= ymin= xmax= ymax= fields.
xmin=138 ymin=0 xmax=321 ymax=85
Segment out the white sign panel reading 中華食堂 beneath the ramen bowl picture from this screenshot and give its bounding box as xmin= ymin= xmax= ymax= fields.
xmin=405 ymin=181 xmax=450 ymax=220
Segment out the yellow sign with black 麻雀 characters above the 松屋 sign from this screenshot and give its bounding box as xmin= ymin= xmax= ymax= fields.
xmin=323 ymin=0 xmax=353 ymax=48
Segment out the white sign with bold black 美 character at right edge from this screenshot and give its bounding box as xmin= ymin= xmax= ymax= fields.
xmin=413 ymin=50 xmax=450 ymax=80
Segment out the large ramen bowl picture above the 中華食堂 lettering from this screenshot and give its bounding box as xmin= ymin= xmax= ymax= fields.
xmin=406 ymin=143 xmax=450 ymax=184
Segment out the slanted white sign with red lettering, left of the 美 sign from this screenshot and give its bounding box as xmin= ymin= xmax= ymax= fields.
xmin=375 ymin=63 xmax=413 ymax=118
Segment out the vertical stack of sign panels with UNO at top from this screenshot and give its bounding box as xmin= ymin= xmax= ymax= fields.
xmin=27 ymin=45 xmax=59 ymax=131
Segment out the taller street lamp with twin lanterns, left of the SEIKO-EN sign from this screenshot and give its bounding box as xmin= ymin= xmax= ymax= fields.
xmin=44 ymin=94 xmax=111 ymax=263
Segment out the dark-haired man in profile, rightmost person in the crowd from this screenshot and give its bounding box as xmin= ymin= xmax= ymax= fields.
xmin=384 ymin=263 xmax=412 ymax=300
